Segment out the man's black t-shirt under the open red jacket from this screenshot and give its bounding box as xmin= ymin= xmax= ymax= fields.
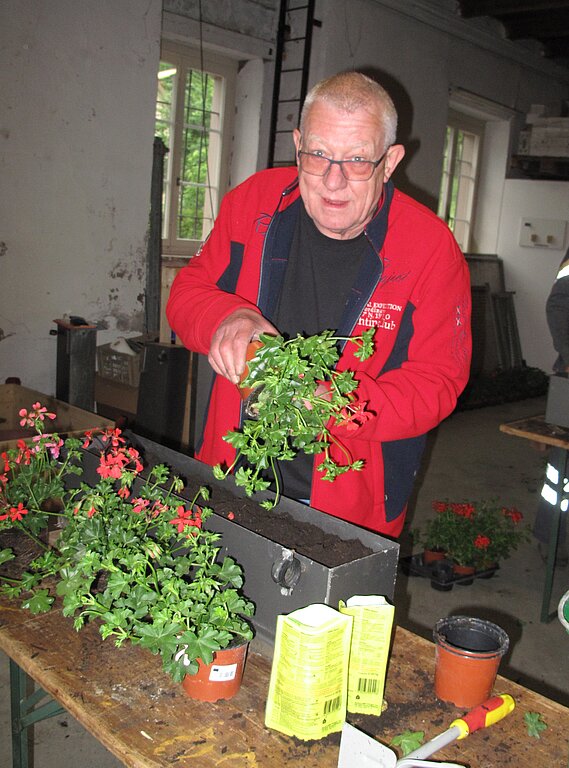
xmin=273 ymin=205 xmax=368 ymax=499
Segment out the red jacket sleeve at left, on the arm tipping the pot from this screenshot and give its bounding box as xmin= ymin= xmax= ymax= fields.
xmin=166 ymin=188 xmax=259 ymax=354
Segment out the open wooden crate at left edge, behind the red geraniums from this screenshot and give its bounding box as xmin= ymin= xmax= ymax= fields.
xmin=0 ymin=384 xmax=114 ymax=451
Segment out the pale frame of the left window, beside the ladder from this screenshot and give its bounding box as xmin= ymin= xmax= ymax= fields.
xmin=155 ymin=41 xmax=237 ymax=257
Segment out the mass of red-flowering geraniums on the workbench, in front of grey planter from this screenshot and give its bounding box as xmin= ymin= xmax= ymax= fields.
xmin=0 ymin=403 xmax=254 ymax=682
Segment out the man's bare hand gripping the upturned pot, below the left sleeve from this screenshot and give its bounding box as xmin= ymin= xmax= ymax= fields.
xmin=207 ymin=309 xmax=278 ymax=384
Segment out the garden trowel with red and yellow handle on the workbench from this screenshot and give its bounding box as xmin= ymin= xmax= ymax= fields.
xmin=338 ymin=693 xmax=515 ymax=768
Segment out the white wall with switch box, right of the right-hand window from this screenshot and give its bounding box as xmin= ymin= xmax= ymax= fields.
xmin=498 ymin=179 xmax=569 ymax=373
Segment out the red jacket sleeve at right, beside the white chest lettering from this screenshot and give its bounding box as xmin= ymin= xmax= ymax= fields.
xmin=335 ymin=232 xmax=472 ymax=442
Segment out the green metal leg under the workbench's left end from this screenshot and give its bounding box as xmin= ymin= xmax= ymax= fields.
xmin=10 ymin=659 xmax=65 ymax=768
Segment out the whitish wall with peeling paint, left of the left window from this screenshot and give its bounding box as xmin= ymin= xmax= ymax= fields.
xmin=0 ymin=0 xmax=162 ymax=394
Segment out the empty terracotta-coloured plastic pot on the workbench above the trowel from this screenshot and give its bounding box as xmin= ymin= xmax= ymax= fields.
xmin=433 ymin=616 xmax=509 ymax=708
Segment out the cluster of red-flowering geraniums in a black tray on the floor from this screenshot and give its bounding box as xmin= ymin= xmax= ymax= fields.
xmin=417 ymin=501 xmax=529 ymax=569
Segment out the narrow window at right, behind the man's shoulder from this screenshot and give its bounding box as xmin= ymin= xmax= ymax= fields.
xmin=437 ymin=115 xmax=484 ymax=251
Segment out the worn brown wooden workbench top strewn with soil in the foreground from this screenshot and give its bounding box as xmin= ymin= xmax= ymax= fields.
xmin=0 ymin=598 xmax=569 ymax=768
